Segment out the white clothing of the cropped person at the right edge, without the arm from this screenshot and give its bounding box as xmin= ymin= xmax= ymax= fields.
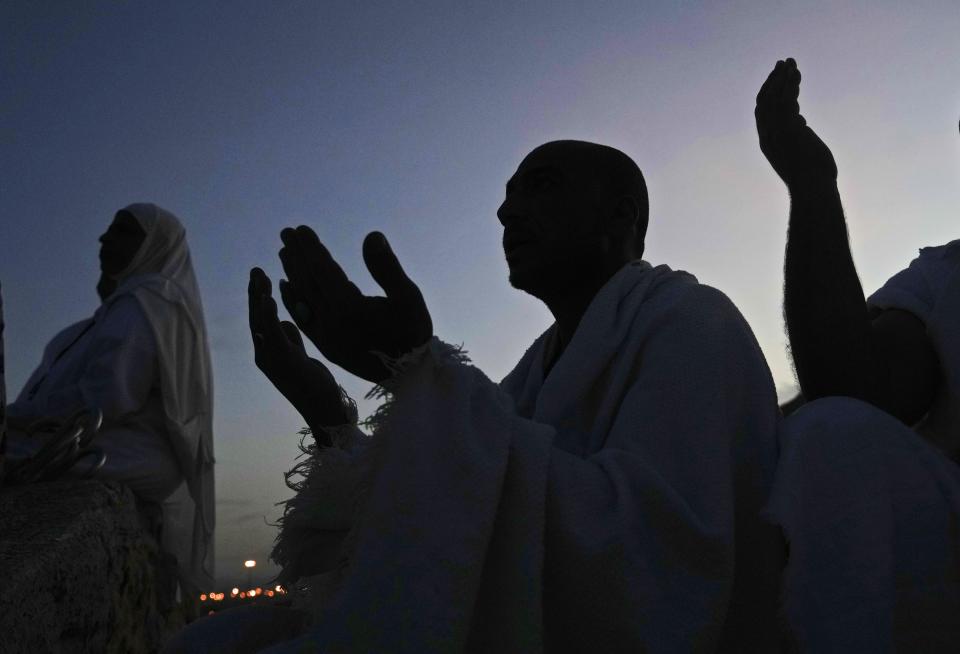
xmin=766 ymin=241 xmax=960 ymax=652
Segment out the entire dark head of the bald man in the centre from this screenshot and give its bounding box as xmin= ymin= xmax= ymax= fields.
xmin=497 ymin=141 xmax=647 ymax=299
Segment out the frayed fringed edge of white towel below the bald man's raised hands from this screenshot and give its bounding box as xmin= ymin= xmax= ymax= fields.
xmin=270 ymin=337 xmax=470 ymax=619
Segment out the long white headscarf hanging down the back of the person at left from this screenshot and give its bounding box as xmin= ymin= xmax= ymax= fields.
xmin=104 ymin=203 xmax=215 ymax=593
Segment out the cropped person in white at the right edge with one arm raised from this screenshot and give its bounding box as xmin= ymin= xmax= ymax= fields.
xmin=756 ymin=59 xmax=960 ymax=652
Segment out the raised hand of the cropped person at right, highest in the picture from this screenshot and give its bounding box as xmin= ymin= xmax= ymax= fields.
xmin=754 ymin=59 xmax=837 ymax=188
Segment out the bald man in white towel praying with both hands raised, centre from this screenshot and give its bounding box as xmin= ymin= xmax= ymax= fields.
xmin=174 ymin=141 xmax=779 ymax=652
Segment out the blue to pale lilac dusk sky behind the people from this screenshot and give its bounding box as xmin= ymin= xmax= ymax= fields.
xmin=0 ymin=0 xmax=960 ymax=590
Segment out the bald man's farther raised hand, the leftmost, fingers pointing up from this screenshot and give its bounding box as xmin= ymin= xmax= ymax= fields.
xmin=247 ymin=268 xmax=351 ymax=438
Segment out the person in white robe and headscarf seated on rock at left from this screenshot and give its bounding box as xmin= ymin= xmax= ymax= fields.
xmin=8 ymin=204 xmax=214 ymax=595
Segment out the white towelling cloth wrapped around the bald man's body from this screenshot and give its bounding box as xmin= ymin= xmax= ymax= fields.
xmin=271 ymin=261 xmax=782 ymax=653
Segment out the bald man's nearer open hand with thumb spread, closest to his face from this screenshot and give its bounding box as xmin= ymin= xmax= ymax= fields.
xmin=280 ymin=225 xmax=433 ymax=383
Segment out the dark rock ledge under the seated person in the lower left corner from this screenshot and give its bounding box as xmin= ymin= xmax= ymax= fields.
xmin=0 ymin=480 xmax=182 ymax=654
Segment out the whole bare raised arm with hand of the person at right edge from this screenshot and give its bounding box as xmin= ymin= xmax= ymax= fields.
xmin=756 ymin=59 xmax=939 ymax=424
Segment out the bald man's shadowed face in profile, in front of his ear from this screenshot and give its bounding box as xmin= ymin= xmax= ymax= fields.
xmin=497 ymin=143 xmax=600 ymax=297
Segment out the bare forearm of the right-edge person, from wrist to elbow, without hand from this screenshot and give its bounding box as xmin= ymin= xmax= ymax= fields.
xmin=784 ymin=180 xmax=871 ymax=400
